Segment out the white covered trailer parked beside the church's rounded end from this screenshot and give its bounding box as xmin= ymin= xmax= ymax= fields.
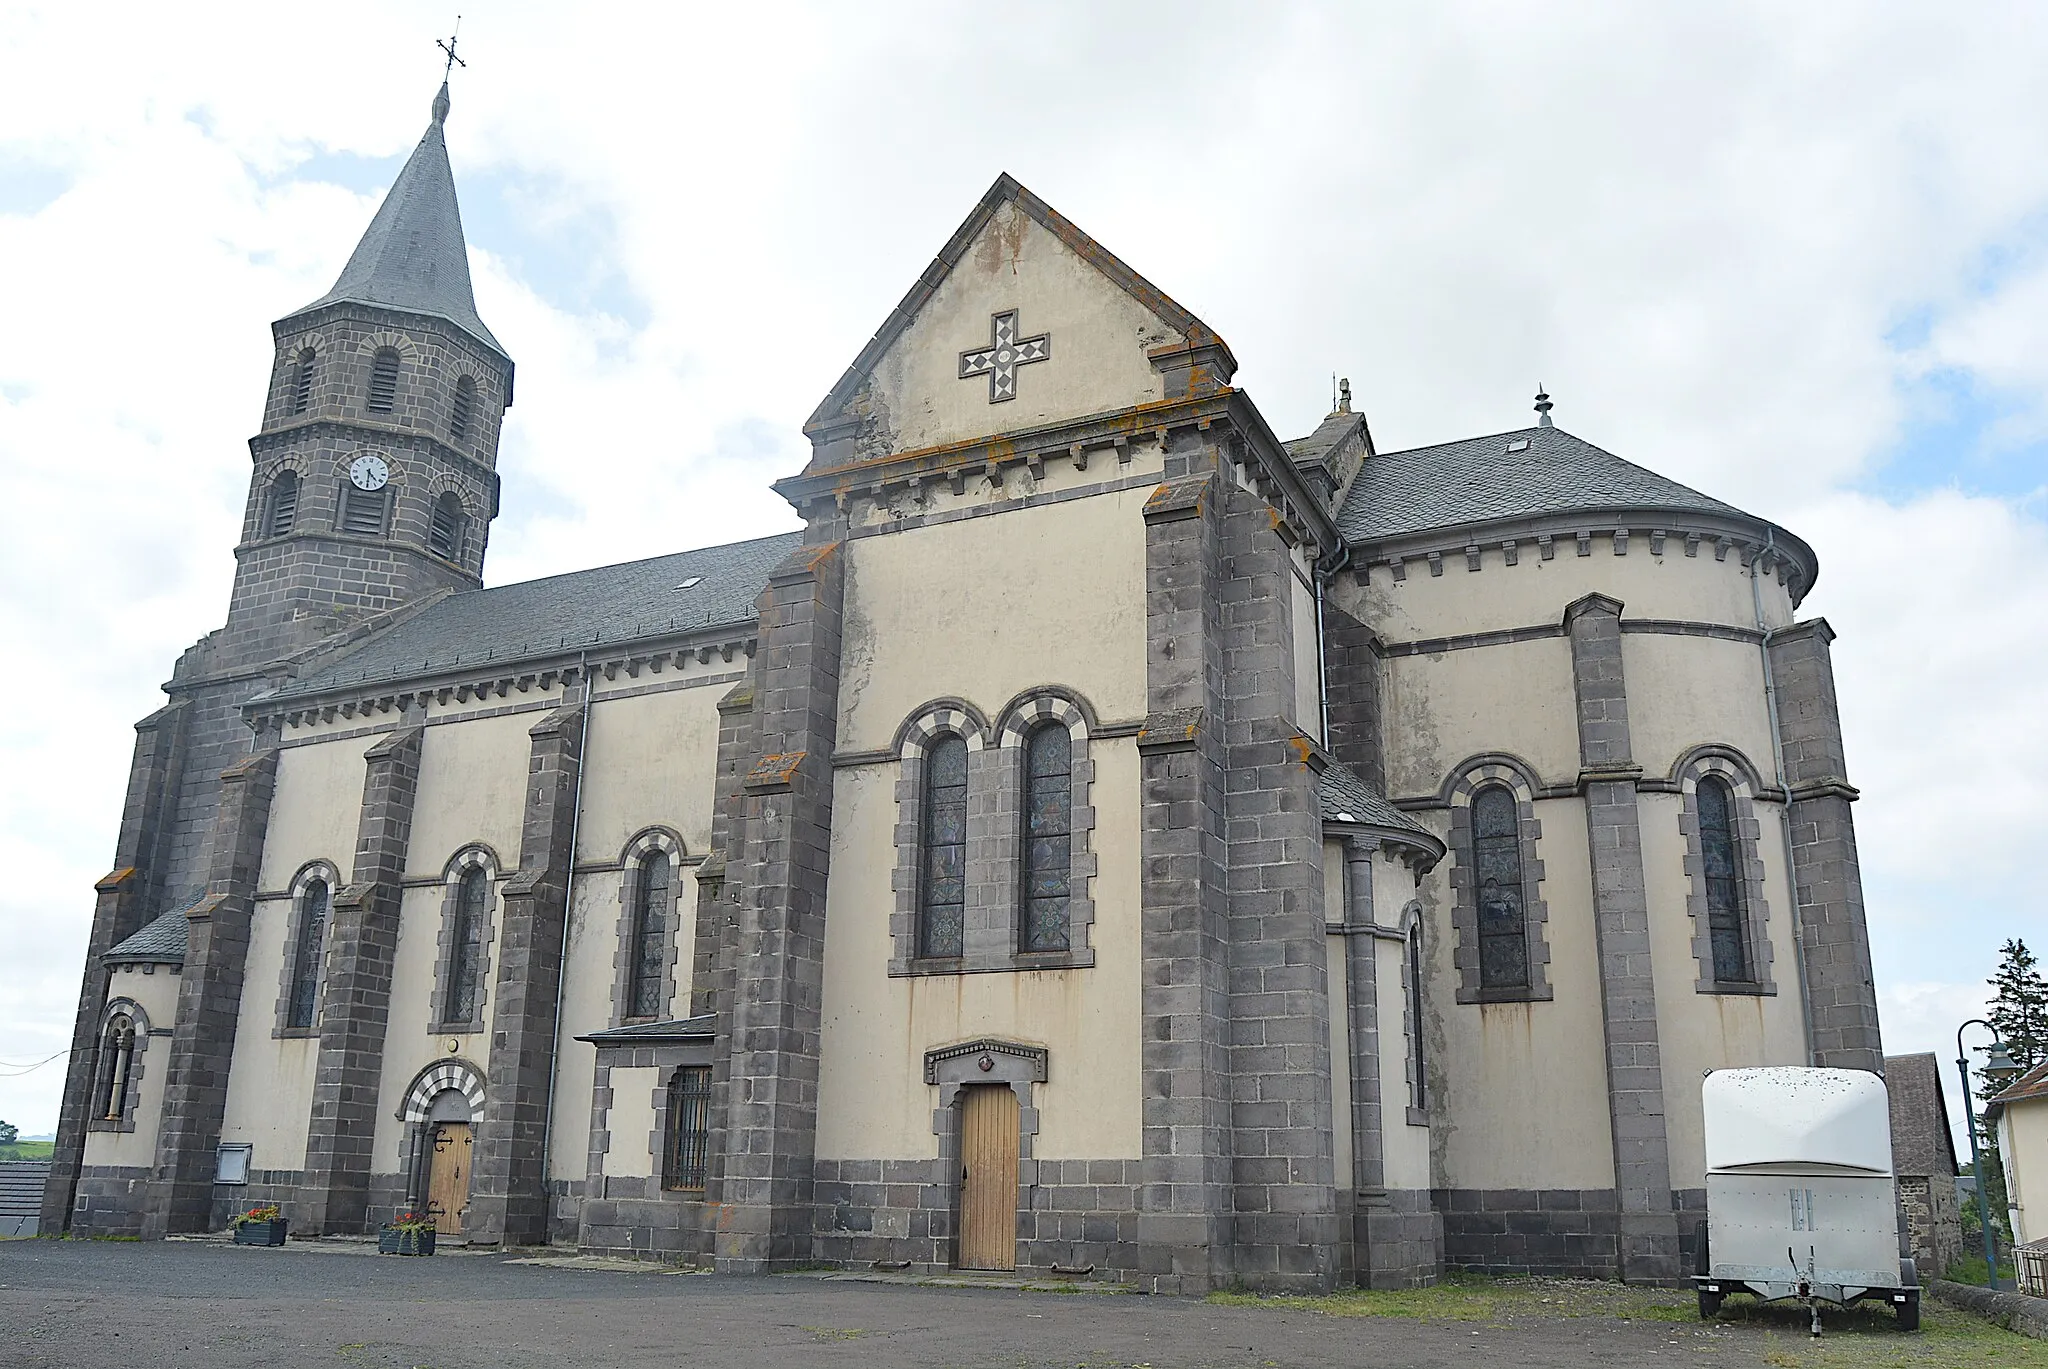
xmin=1694 ymin=1066 xmax=1921 ymax=1336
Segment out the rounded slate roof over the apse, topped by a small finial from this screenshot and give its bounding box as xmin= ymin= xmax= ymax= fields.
xmin=1337 ymin=428 xmax=1753 ymax=541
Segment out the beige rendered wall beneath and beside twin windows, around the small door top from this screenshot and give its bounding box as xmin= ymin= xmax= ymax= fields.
xmin=817 ymin=740 xmax=1141 ymax=1160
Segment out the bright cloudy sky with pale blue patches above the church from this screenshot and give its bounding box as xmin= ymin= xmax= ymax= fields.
xmin=0 ymin=0 xmax=2048 ymax=1133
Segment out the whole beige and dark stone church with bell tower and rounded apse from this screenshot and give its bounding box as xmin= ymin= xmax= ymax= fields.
xmin=43 ymin=86 xmax=1882 ymax=1293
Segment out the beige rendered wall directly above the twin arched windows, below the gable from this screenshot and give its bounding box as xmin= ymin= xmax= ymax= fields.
xmin=834 ymin=481 xmax=1149 ymax=750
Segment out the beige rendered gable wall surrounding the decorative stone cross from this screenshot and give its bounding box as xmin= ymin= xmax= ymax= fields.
xmin=868 ymin=203 xmax=1178 ymax=455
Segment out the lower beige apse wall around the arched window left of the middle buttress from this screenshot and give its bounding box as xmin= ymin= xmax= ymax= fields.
xmin=1423 ymin=799 xmax=1614 ymax=1189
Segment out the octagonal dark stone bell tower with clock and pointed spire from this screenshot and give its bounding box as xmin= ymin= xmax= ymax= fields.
xmin=209 ymin=82 xmax=512 ymax=670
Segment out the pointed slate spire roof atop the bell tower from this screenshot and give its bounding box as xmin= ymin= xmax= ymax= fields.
xmin=289 ymin=82 xmax=510 ymax=361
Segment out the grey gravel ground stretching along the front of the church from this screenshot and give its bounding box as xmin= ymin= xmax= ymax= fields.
xmin=0 ymin=1240 xmax=2048 ymax=1369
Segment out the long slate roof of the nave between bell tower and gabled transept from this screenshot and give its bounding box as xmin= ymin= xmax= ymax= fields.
xmin=262 ymin=533 xmax=803 ymax=703
